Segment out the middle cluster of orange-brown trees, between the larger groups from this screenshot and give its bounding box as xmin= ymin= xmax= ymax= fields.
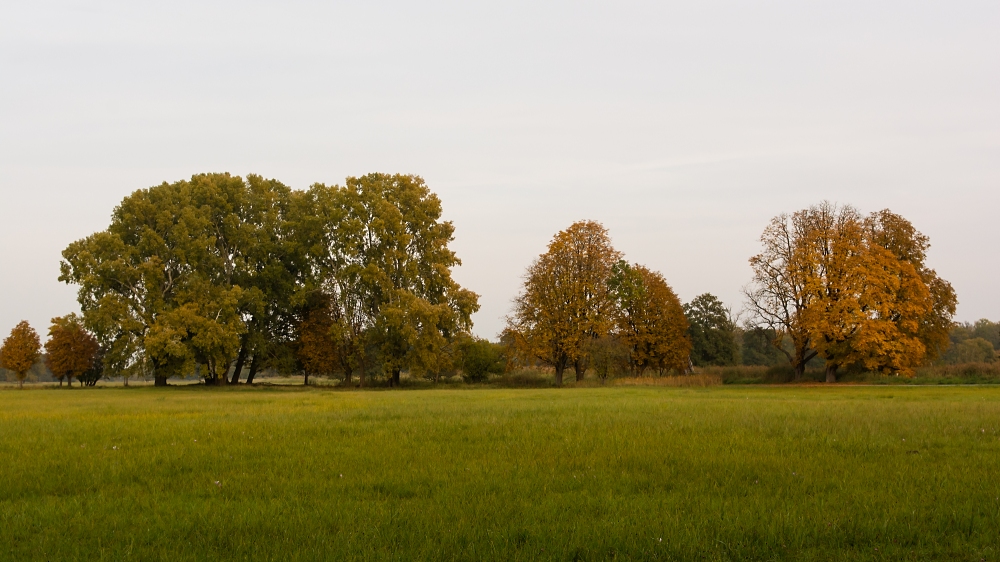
xmin=501 ymin=221 xmax=691 ymax=384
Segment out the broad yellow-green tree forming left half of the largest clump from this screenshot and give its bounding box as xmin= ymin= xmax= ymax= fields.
xmin=60 ymin=174 xmax=293 ymax=385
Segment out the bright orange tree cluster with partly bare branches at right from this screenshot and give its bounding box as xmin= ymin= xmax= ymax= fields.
xmin=744 ymin=203 xmax=957 ymax=382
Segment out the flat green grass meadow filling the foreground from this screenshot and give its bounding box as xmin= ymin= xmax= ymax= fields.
xmin=0 ymin=386 xmax=1000 ymax=560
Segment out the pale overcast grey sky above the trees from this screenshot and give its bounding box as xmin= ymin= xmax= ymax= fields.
xmin=0 ymin=0 xmax=1000 ymax=337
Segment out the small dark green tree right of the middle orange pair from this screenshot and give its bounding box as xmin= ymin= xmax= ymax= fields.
xmin=684 ymin=293 xmax=739 ymax=367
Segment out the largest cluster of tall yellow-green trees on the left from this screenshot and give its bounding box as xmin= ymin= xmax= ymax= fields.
xmin=60 ymin=174 xmax=479 ymax=385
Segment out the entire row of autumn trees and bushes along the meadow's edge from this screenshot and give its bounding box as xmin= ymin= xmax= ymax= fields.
xmin=0 ymin=174 xmax=988 ymax=385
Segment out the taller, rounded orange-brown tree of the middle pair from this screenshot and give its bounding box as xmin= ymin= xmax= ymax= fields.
xmin=507 ymin=221 xmax=621 ymax=385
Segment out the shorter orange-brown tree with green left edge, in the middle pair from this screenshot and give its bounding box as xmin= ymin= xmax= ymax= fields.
xmin=608 ymin=260 xmax=691 ymax=375
